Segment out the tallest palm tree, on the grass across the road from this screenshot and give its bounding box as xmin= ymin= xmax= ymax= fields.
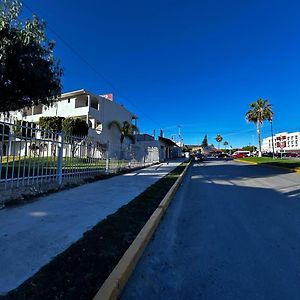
xmin=246 ymin=98 xmax=273 ymax=156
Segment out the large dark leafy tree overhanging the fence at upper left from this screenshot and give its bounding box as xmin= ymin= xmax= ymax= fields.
xmin=0 ymin=0 xmax=62 ymax=113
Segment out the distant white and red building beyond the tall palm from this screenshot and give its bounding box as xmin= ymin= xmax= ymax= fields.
xmin=261 ymin=131 xmax=300 ymax=153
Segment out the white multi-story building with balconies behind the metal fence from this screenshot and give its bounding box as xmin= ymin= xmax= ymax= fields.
xmin=2 ymin=89 xmax=137 ymax=154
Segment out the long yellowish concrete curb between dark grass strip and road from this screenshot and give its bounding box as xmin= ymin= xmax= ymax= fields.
xmin=93 ymin=162 xmax=191 ymax=300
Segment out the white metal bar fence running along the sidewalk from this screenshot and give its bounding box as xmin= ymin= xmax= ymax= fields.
xmin=0 ymin=121 xmax=157 ymax=190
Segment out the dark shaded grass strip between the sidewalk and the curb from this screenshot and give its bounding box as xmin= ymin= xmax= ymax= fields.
xmin=0 ymin=163 xmax=187 ymax=300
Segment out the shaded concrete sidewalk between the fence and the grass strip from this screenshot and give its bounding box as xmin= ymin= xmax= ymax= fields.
xmin=0 ymin=160 xmax=183 ymax=294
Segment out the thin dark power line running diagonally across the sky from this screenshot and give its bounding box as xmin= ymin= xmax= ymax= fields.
xmin=22 ymin=1 xmax=157 ymax=124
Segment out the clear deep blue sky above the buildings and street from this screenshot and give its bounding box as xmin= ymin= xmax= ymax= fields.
xmin=23 ymin=0 xmax=300 ymax=147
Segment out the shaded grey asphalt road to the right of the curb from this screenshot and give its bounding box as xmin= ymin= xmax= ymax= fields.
xmin=121 ymin=160 xmax=300 ymax=300
